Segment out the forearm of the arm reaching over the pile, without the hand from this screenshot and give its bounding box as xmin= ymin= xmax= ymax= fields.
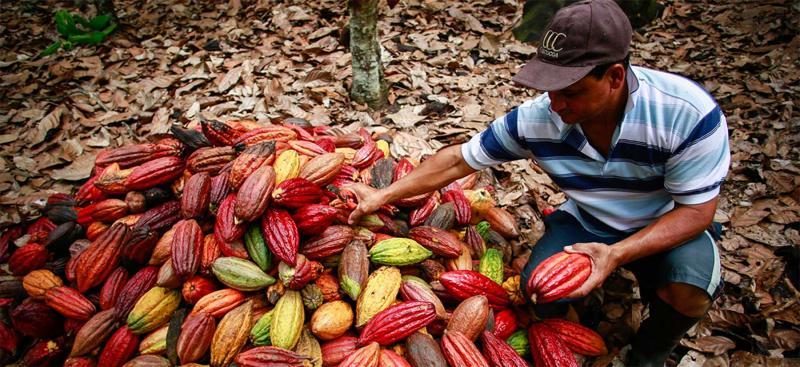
xmin=379 ymin=145 xmax=475 ymax=202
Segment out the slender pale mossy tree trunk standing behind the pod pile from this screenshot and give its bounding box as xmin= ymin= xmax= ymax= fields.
xmin=349 ymin=0 xmax=386 ymax=109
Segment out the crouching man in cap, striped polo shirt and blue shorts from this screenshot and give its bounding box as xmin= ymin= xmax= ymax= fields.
xmin=350 ymin=0 xmax=730 ymax=366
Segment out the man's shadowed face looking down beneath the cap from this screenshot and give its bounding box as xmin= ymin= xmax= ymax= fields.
xmin=547 ymin=65 xmax=624 ymax=124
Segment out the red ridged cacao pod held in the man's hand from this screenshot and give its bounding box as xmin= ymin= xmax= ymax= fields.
xmin=527 ymin=251 xmax=592 ymax=303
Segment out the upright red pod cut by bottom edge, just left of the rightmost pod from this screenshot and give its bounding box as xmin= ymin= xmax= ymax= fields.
xmin=528 ymin=323 xmax=578 ymax=367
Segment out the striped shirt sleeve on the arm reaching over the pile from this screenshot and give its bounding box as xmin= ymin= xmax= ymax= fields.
xmin=461 ymin=108 xmax=532 ymax=170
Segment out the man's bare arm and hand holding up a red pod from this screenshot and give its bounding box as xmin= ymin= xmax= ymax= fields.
xmin=564 ymin=197 xmax=718 ymax=298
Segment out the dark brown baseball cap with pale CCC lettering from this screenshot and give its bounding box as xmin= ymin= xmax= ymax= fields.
xmin=513 ymin=0 xmax=633 ymax=91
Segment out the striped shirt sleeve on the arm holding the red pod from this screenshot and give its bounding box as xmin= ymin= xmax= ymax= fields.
xmin=664 ymin=106 xmax=731 ymax=205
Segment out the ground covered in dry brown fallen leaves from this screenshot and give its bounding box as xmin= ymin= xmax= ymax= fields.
xmin=0 ymin=0 xmax=800 ymax=366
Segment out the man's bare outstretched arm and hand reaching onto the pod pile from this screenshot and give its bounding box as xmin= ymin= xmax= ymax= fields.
xmin=346 ymin=145 xmax=475 ymax=224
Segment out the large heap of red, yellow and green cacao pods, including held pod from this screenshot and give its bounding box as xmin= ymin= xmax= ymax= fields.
xmin=0 ymin=119 xmax=606 ymax=367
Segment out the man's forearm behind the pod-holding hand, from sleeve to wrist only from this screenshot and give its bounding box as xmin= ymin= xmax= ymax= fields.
xmin=611 ymin=198 xmax=717 ymax=266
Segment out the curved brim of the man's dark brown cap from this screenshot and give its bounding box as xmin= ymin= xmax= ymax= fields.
xmin=512 ymin=57 xmax=594 ymax=91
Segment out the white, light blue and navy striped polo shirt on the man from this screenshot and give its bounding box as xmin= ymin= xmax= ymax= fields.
xmin=461 ymin=66 xmax=730 ymax=235
